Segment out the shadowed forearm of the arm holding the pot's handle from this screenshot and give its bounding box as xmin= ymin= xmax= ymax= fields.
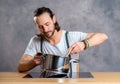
xmin=18 ymin=60 xmax=37 ymax=72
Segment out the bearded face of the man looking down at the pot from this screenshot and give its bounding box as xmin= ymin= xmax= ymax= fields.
xmin=36 ymin=13 xmax=55 ymax=38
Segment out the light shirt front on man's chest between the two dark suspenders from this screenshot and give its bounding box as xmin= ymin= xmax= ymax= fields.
xmin=41 ymin=37 xmax=68 ymax=56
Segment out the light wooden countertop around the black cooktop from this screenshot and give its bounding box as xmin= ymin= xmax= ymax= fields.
xmin=0 ymin=72 xmax=120 ymax=84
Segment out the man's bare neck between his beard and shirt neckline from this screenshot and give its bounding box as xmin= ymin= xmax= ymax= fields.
xmin=47 ymin=30 xmax=62 ymax=45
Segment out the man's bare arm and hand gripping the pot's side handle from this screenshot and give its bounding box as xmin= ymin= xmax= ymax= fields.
xmin=18 ymin=54 xmax=40 ymax=72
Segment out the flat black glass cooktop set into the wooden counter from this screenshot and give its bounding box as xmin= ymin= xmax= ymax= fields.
xmin=23 ymin=72 xmax=94 ymax=78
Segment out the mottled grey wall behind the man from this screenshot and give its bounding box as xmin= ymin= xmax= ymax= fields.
xmin=0 ymin=0 xmax=120 ymax=71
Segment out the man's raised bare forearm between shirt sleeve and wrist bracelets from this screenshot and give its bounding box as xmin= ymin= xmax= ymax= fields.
xmin=87 ymin=33 xmax=108 ymax=47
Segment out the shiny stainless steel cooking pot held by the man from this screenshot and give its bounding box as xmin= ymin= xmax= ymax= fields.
xmin=42 ymin=54 xmax=70 ymax=73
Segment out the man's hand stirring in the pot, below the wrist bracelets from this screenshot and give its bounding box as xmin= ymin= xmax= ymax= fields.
xmin=69 ymin=42 xmax=85 ymax=54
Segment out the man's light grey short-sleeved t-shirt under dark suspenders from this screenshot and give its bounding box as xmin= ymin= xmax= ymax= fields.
xmin=24 ymin=30 xmax=87 ymax=58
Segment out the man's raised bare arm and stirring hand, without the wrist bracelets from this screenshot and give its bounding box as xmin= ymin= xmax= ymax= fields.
xmin=69 ymin=33 xmax=108 ymax=54
